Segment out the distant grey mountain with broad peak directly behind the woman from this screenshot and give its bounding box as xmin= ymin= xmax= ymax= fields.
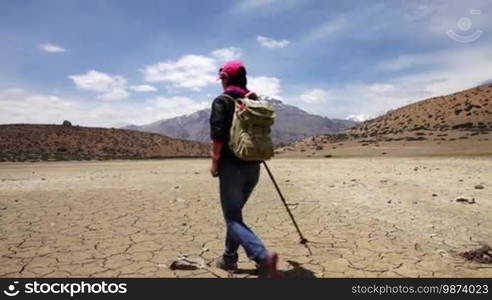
xmin=124 ymin=98 xmax=357 ymax=144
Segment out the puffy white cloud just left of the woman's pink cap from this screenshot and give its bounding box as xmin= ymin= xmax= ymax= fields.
xmin=144 ymin=54 xmax=217 ymax=91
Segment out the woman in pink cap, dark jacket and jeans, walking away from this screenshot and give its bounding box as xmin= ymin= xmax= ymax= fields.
xmin=210 ymin=61 xmax=278 ymax=277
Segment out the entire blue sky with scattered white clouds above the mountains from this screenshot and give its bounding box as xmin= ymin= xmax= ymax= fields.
xmin=0 ymin=0 xmax=492 ymax=126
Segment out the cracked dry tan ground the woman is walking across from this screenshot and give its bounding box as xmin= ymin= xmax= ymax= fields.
xmin=0 ymin=157 xmax=492 ymax=277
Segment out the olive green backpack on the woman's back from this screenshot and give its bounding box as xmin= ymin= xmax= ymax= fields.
xmin=224 ymin=94 xmax=275 ymax=161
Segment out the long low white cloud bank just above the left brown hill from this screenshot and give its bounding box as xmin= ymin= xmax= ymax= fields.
xmin=0 ymin=89 xmax=210 ymax=127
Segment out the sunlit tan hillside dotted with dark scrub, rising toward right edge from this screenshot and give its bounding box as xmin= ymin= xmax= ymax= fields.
xmin=277 ymin=84 xmax=492 ymax=157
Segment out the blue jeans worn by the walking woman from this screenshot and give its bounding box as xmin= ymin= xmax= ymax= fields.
xmin=219 ymin=158 xmax=267 ymax=262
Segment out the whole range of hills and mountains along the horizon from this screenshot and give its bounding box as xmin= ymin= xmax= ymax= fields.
xmin=0 ymin=84 xmax=492 ymax=161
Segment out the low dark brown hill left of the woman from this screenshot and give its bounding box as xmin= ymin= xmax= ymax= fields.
xmin=0 ymin=121 xmax=209 ymax=161
